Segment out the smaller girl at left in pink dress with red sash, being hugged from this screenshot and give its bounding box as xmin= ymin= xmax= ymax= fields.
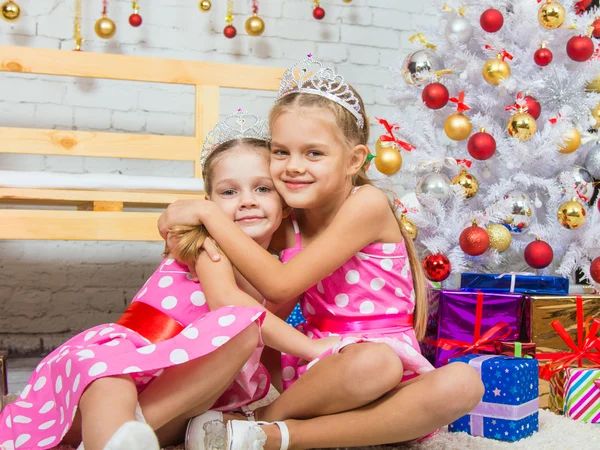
xmin=0 ymin=111 xmax=328 ymax=450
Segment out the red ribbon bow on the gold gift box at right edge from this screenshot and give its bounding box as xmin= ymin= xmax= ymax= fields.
xmin=535 ymin=295 xmax=600 ymax=380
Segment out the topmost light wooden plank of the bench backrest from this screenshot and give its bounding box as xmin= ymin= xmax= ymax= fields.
xmin=0 ymin=46 xmax=284 ymax=91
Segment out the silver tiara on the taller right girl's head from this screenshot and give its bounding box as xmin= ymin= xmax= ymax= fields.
xmin=277 ymin=54 xmax=365 ymax=128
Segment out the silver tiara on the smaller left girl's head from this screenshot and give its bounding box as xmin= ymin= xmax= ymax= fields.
xmin=200 ymin=109 xmax=269 ymax=170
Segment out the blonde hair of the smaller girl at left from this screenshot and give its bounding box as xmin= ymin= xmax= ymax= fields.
xmin=163 ymin=138 xmax=269 ymax=267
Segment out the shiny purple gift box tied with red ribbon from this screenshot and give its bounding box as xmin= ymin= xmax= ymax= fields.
xmin=422 ymin=290 xmax=529 ymax=367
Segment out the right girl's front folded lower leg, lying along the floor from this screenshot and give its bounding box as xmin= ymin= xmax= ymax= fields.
xmin=263 ymin=363 xmax=484 ymax=450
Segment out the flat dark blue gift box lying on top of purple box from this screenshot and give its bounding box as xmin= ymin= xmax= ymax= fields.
xmin=460 ymin=272 xmax=569 ymax=295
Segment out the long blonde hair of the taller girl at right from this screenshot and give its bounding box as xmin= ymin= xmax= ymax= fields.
xmin=269 ymin=90 xmax=427 ymax=340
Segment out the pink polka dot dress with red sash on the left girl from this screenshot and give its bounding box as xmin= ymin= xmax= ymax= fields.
xmin=0 ymin=259 xmax=269 ymax=450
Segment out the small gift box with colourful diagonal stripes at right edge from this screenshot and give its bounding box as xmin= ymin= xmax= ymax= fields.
xmin=565 ymin=367 xmax=600 ymax=423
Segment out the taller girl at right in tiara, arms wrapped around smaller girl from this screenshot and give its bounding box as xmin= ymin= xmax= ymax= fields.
xmin=159 ymin=55 xmax=483 ymax=450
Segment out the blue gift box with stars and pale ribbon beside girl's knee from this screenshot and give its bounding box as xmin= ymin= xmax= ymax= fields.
xmin=448 ymin=355 xmax=539 ymax=441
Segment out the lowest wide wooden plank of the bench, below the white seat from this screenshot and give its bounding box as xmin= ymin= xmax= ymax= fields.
xmin=0 ymin=209 xmax=162 ymax=241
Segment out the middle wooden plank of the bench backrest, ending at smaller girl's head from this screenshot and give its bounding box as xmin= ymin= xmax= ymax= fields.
xmin=0 ymin=127 xmax=199 ymax=161
